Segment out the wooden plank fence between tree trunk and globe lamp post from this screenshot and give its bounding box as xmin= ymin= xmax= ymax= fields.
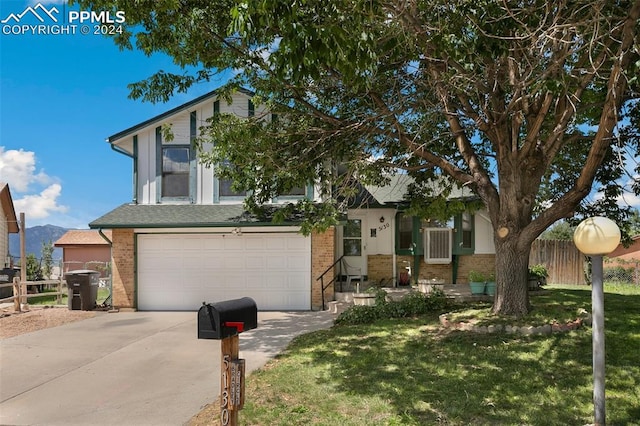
xmin=529 ymin=240 xmax=587 ymax=285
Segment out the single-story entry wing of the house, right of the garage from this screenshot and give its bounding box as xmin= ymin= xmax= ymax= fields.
xmin=336 ymin=174 xmax=495 ymax=286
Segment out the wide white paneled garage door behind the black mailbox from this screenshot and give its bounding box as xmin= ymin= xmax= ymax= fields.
xmin=138 ymin=233 xmax=311 ymax=310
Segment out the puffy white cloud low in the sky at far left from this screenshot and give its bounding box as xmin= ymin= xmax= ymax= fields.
xmin=0 ymin=146 xmax=68 ymax=219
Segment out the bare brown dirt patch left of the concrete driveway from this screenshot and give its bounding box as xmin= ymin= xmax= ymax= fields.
xmin=0 ymin=307 xmax=96 ymax=339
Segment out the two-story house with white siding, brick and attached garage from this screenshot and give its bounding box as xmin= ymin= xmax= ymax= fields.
xmin=89 ymin=90 xmax=495 ymax=310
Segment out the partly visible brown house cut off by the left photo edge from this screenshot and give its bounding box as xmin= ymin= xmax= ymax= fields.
xmin=0 ymin=182 xmax=20 ymax=299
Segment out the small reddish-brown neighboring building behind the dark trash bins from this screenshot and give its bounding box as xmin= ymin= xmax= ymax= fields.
xmin=53 ymin=229 xmax=111 ymax=276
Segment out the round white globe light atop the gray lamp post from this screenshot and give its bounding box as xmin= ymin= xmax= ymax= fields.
xmin=573 ymin=216 xmax=620 ymax=256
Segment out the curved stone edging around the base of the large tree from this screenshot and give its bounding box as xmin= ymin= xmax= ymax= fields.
xmin=439 ymin=309 xmax=591 ymax=335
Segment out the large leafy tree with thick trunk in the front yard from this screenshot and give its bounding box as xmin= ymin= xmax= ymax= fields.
xmin=79 ymin=0 xmax=640 ymax=315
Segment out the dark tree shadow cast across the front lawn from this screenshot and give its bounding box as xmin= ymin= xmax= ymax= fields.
xmin=308 ymin=290 xmax=640 ymax=425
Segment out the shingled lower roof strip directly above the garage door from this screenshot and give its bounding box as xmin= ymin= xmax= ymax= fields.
xmin=89 ymin=204 xmax=298 ymax=229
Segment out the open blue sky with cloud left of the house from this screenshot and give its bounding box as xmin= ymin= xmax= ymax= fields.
xmin=0 ymin=0 xmax=230 ymax=228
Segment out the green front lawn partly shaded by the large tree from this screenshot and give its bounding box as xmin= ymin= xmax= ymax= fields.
xmin=240 ymin=286 xmax=640 ymax=426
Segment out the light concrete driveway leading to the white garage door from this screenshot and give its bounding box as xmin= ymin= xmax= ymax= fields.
xmin=0 ymin=311 xmax=334 ymax=425
